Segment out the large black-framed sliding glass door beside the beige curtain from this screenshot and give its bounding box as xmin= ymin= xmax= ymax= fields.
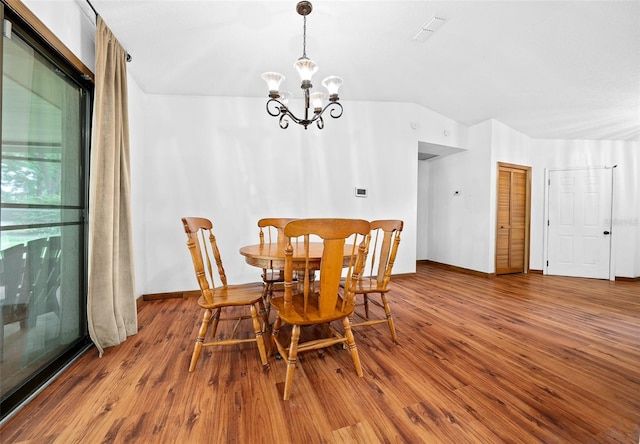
xmin=0 ymin=4 xmax=91 ymax=417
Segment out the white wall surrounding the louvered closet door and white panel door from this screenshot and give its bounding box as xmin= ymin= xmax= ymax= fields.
xmin=489 ymin=121 xmax=640 ymax=277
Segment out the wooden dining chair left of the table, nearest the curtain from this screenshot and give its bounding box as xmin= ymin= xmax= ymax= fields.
xmin=182 ymin=217 xmax=269 ymax=372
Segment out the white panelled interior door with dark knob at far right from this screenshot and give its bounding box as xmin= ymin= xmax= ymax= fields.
xmin=546 ymin=168 xmax=612 ymax=279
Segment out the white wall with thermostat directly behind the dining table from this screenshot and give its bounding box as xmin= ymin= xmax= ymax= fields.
xmin=140 ymin=95 xmax=430 ymax=293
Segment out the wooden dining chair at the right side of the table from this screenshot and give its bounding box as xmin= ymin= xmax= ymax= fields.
xmin=342 ymin=220 xmax=404 ymax=344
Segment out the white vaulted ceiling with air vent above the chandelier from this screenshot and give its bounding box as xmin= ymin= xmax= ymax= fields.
xmin=90 ymin=0 xmax=640 ymax=141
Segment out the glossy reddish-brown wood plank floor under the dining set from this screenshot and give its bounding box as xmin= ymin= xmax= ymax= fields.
xmin=0 ymin=263 xmax=640 ymax=444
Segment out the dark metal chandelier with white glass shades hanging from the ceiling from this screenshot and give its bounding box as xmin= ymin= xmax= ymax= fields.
xmin=262 ymin=1 xmax=342 ymax=129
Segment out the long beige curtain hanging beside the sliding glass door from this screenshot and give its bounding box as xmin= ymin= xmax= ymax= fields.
xmin=87 ymin=17 xmax=138 ymax=356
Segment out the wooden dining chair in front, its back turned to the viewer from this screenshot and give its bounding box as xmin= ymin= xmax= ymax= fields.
xmin=271 ymin=219 xmax=369 ymax=400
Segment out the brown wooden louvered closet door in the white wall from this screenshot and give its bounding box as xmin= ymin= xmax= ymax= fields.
xmin=496 ymin=164 xmax=531 ymax=274
